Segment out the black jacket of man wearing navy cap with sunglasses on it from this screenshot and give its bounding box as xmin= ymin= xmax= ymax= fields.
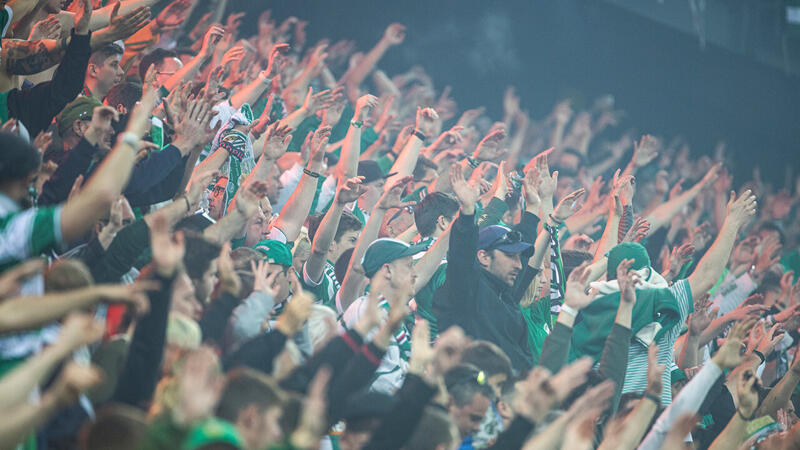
xmin=433 ymin=212 xmax=539 ymax=370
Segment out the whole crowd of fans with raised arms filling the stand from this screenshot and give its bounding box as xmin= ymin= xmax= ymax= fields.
xmin=0 ymin=0 xmax=800 ymax=450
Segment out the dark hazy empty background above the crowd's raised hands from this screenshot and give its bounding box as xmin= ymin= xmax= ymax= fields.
xmin=229 ymin=0 xmax=800 ymax=182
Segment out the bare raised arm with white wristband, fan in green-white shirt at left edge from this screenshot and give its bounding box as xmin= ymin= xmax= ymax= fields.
xmin=61 ymin=69 xmax=157 ymax=242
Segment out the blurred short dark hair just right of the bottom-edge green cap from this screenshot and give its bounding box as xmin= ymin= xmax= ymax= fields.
xmin=217 ymin=367 xmax=283 ymax=423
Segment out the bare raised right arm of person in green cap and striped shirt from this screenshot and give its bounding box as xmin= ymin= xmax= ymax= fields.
xmin=689 ymin=190 xmax=756 ymax=300
